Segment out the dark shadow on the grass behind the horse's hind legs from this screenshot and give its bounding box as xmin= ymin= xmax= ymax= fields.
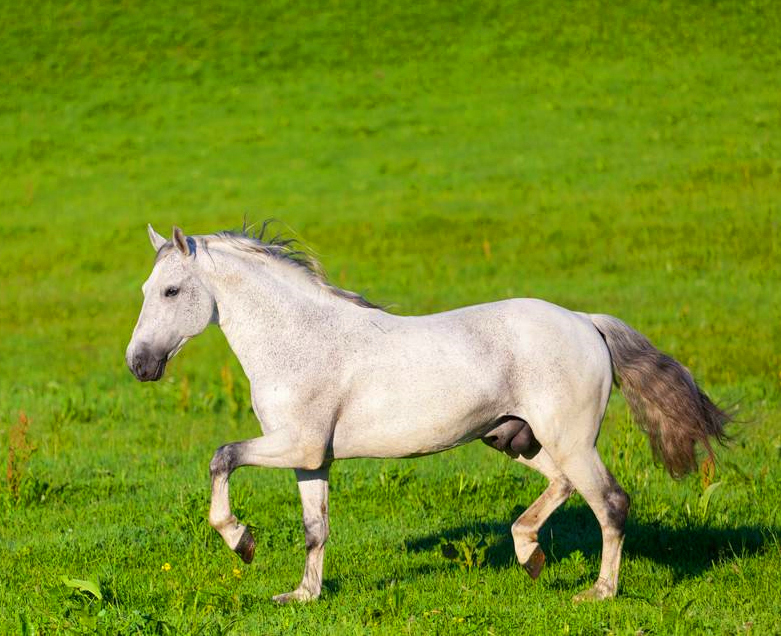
xmin=406 ymin=505 xmax=779 ymax=580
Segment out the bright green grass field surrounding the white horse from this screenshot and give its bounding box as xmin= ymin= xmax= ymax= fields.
xmin=0 ymin=0 xmax=781 ymax=634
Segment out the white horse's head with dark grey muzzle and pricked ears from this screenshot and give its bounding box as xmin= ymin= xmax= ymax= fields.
xmin=125 ymin=225 xmax=217 ymax=382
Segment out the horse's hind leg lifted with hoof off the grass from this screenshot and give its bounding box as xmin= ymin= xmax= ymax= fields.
xmin=512 ymin=449 xmax=573 ymax=579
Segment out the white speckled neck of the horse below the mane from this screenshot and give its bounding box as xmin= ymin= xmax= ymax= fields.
xmin=204 ymin=255 xmax=354 ymax=382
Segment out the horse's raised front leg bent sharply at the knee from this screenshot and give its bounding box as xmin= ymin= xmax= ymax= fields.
xmin=209 ymin=429 xmax=326 ymax=563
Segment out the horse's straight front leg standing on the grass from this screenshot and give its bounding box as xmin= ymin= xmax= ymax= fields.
xmin=274 ymin=467 xmax=328 ymax=603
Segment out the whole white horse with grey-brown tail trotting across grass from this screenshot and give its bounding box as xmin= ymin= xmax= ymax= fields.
xmin=126 ymin=224 xmax=728 ymax=602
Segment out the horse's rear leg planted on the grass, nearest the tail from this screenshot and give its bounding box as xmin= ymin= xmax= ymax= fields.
xmin=556 ymin=445 xmax=629 ymax=601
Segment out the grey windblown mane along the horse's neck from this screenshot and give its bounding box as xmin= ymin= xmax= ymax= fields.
xmin=202 ymin=219 xmax=382 ymax=309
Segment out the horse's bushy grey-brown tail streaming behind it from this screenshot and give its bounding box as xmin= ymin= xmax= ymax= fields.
xmin=589 ymin=314 xmax=731 ymax=477
